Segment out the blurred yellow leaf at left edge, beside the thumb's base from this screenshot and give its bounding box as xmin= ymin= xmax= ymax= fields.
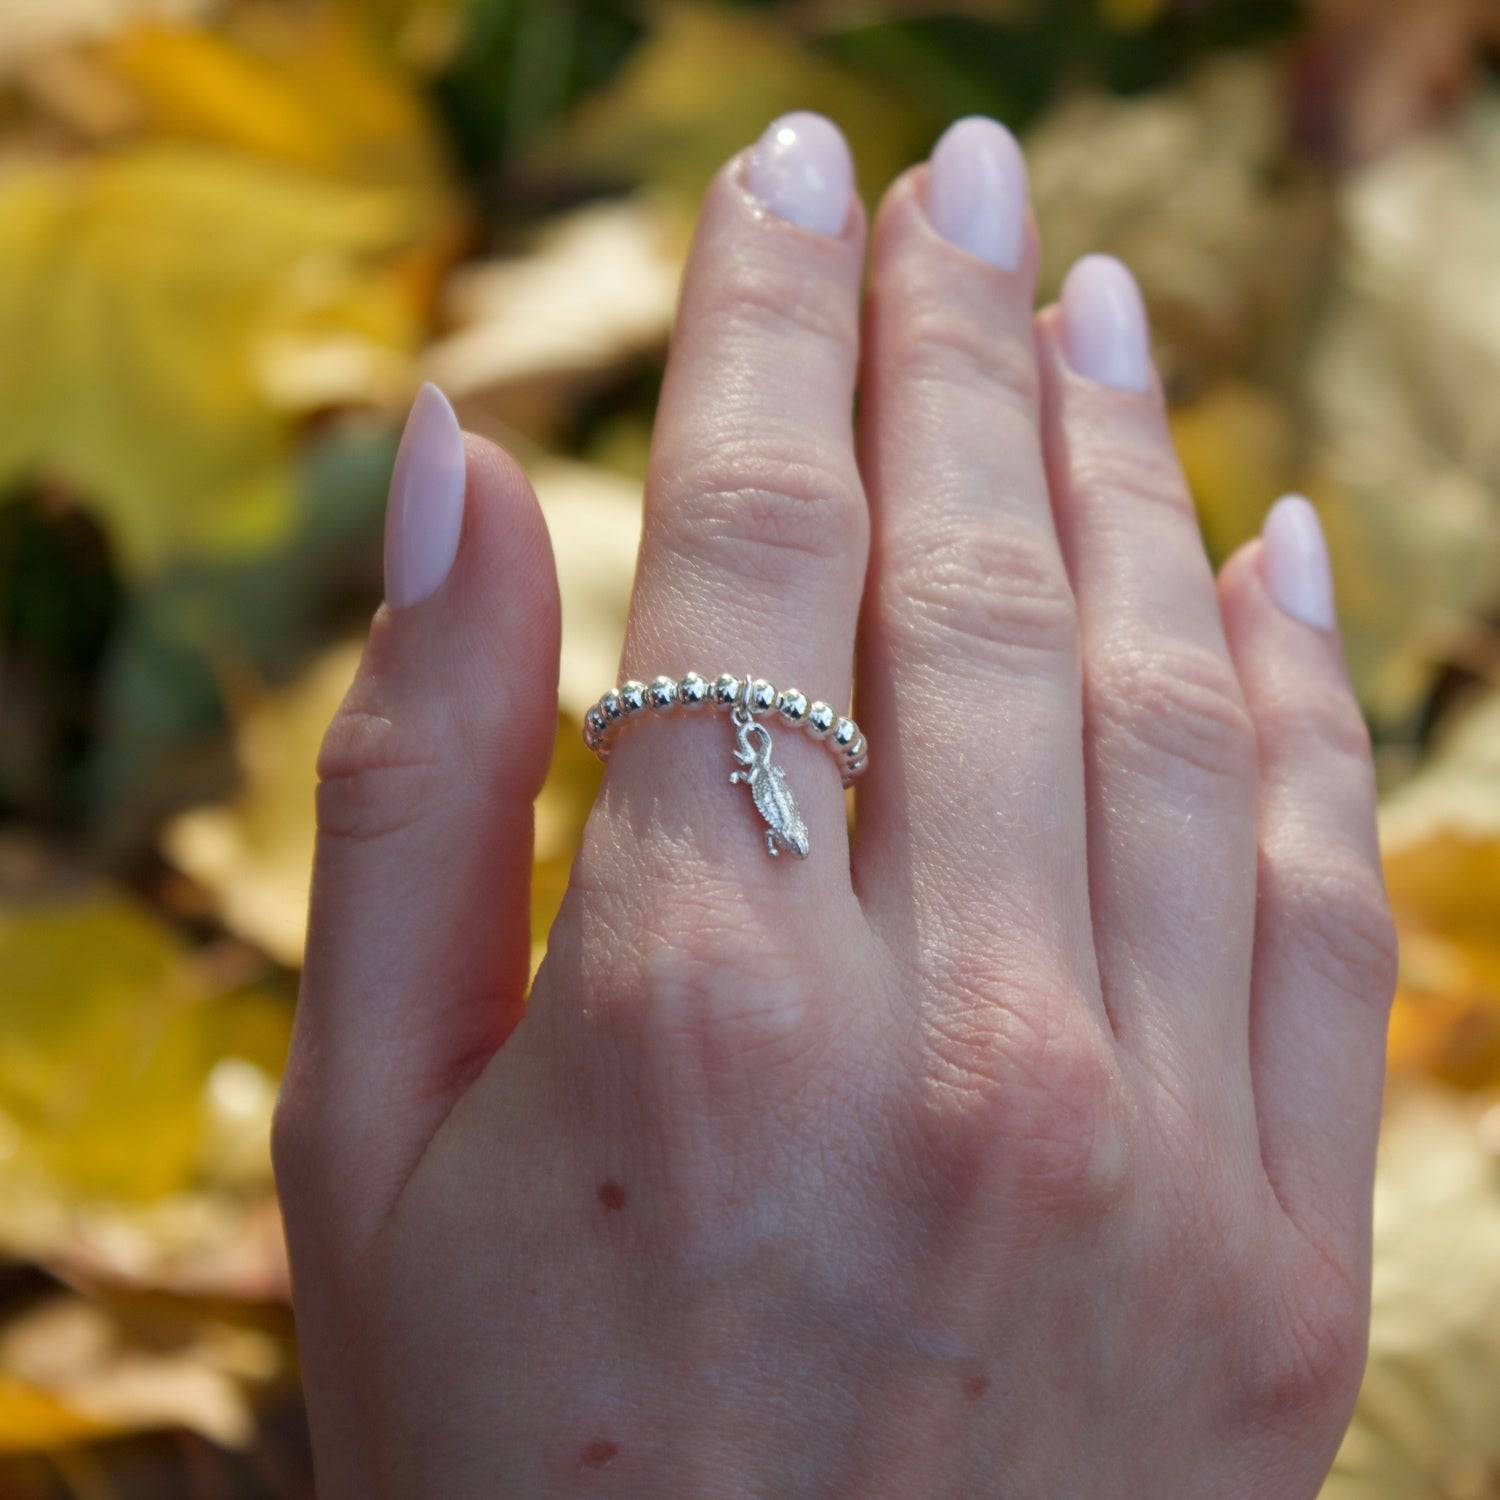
xmin=0 ymin=890 xmax=291 ymax=1296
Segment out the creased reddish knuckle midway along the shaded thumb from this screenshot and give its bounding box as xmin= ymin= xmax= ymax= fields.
xmin=315 ymin=704 xmax=449 ymax=843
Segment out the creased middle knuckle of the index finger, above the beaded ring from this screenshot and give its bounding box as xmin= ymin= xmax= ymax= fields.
xmin=653 ymin=437 xmax=869 ymax=584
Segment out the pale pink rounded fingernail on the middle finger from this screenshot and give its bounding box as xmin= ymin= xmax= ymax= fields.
xmin=927 ymin=116 xmax=1026 ymax=272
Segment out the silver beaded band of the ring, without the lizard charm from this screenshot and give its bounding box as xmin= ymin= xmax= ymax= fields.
xmin=584 ymin=672 xmax=870 ymax=786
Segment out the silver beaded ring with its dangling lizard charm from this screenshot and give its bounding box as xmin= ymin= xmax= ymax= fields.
xmin=584 ymin=672 xmax=870 ymax=860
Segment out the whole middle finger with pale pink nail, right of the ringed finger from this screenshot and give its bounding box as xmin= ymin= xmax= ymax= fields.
xmin=855 ymin=119 xmax=1103 ymax=1020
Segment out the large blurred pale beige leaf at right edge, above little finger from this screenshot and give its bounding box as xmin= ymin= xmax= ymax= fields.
xmin=1305 ymin=92 xmax=1500 ymax=728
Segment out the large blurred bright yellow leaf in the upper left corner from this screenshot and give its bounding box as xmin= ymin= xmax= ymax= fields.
xmin=0 ymin=11 xmax=452 ymax=570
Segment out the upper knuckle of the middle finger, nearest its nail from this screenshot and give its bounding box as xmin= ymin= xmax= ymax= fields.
xmin=887 ymin=296 xmax=1040 ymax=422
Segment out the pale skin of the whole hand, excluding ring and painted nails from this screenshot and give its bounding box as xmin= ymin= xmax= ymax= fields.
xmin=275 ymin=117 xmax=1395 ymax=1500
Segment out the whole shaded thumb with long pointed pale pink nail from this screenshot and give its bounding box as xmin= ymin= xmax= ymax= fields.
xmin=275 ymin=386 xmax=558 ymax=1214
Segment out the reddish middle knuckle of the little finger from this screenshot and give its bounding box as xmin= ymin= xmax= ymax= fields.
xmin=1262 ymin=849 xmax=1400 ymax=1008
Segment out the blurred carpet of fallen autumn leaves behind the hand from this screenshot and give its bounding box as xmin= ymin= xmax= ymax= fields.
xmin=0 ymin=0 xmax=1500 ymax=1500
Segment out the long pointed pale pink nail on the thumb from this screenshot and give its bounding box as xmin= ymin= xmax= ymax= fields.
xmin=386 ymin=384 xmax=467 ymax=609
